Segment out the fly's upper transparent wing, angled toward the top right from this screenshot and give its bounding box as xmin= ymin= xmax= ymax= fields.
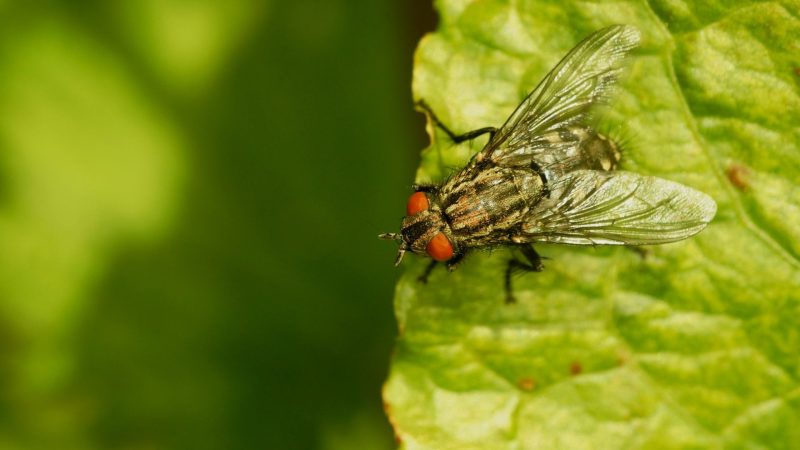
xmin=483 ymin=25 xmax=639 ymax=166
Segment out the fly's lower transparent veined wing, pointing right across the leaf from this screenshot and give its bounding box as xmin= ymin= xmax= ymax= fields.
xmin=521 ymin=170 xmax=717 ymax=245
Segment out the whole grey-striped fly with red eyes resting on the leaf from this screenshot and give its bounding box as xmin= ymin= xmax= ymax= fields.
xmin=379 ymin=25 xmax=717 ymax=303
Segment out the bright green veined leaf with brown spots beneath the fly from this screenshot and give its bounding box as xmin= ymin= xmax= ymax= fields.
xmin=384 ymin=0 xmax=800 ymax=450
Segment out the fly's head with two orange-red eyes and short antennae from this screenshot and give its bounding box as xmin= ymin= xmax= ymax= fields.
xmin=378 ymin=191 xmax=459 ymax=265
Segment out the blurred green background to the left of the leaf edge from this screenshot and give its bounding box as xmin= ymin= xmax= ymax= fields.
xmin=0 ymin=0 xmax=435 ymax=449
